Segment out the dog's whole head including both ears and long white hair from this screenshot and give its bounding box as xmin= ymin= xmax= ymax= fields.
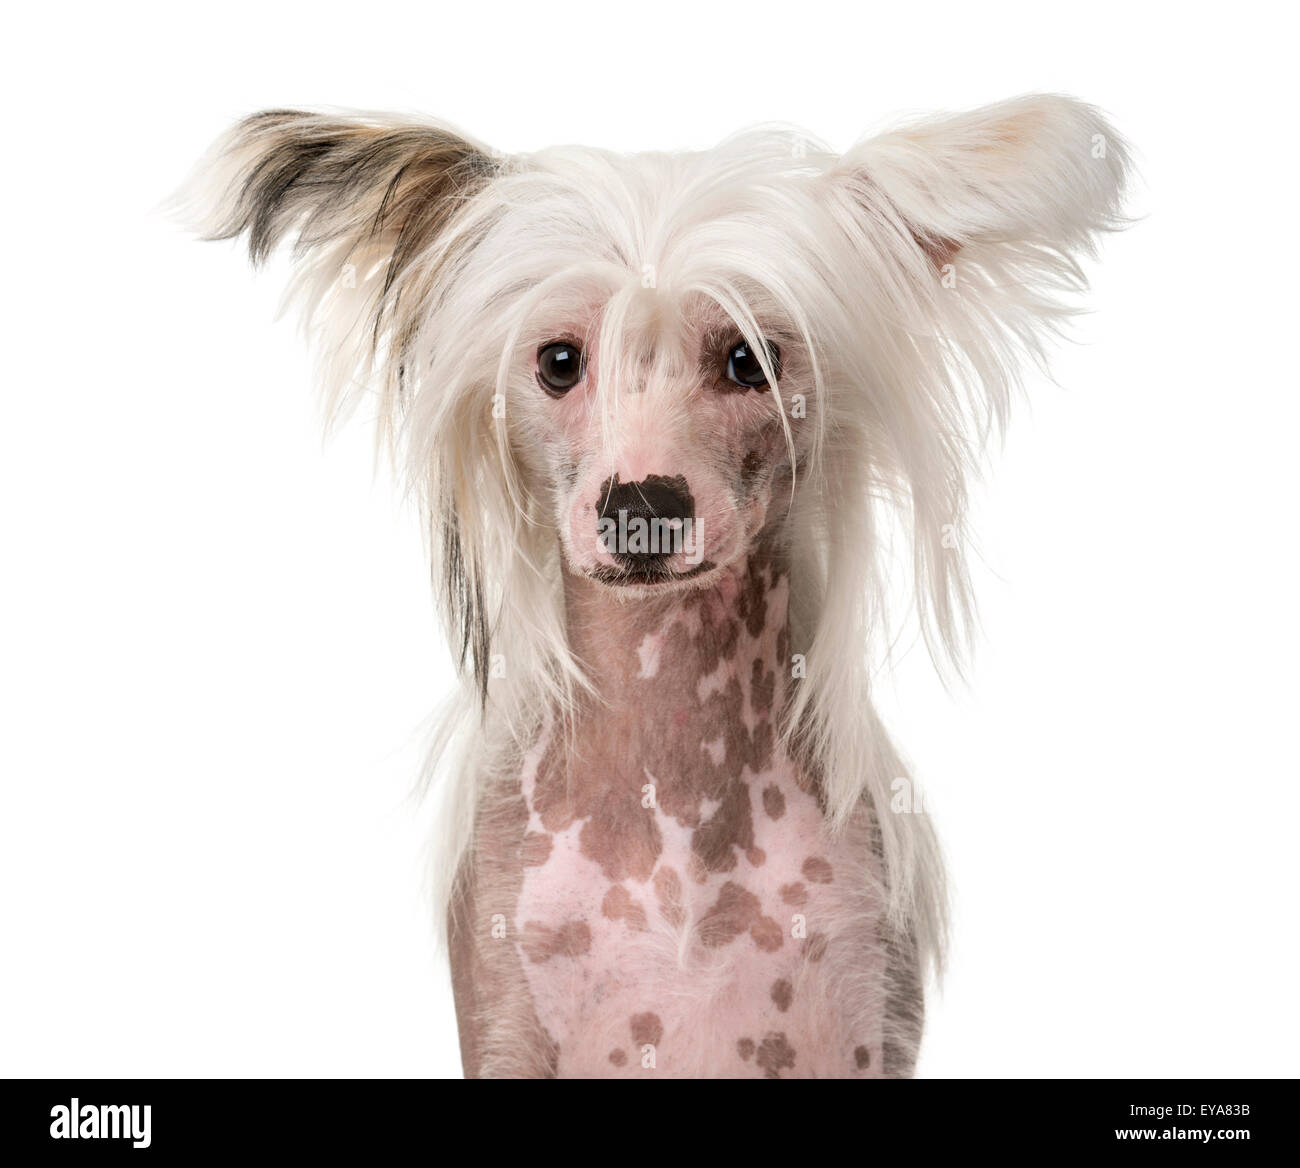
xmin=183 ymin=98 xmax=1126 ymax=691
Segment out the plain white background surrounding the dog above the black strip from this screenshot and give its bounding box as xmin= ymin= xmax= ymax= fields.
xmin=0 ymin=0 xmax=1300 ymax=1076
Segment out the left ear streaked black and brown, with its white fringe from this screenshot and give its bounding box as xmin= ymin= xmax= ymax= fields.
xmin=174 ymin=111 xmax=498 ymax=414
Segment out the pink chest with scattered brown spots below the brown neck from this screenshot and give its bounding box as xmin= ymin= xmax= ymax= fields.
xmin=514 ymin=749 xmax=883 ymax=1078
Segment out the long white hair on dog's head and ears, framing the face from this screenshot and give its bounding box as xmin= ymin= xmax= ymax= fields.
xmin=181 ymin=96 xmax=1128 ymax=983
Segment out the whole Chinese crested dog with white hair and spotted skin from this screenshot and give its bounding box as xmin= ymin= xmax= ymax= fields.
xmin=185 ymin=96 xmax=1128 ymax=1078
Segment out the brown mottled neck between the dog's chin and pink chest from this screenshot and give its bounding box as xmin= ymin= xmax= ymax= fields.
xmin=532 ymin=533 xmax=806 ymax=882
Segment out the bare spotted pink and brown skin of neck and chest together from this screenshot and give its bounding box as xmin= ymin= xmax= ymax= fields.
xmin=452 ymin=541 xmax=919 ymax=1078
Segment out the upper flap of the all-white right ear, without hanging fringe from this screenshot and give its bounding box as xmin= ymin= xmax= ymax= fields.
xmin=837 ymin=95 xmax=1128 ymax=268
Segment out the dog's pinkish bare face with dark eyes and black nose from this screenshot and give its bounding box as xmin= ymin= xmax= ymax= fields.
xmin=517 ymin=286 xmax=798 ymax=594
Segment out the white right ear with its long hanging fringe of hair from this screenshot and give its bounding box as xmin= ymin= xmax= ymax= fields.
xmin=824 ymin=96 xmax=1130 ymax=666
